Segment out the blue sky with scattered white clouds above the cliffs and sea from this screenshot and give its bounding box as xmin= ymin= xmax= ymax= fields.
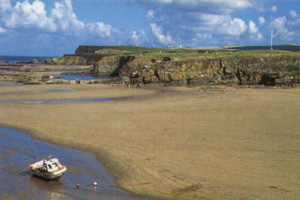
xmin=0 ymin=0 xmax=300 ymax=56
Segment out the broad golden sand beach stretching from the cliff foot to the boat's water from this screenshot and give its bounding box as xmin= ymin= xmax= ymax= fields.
xmin=0 ymin=84 xmax=300 ymax=200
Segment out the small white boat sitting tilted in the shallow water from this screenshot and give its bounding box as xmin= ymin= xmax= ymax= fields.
xmin=28 ymin=158 xmax=67 ymax=180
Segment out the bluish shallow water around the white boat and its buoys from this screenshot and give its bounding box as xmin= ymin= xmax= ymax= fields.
xmin=0 ymin=126 xmax=156 ymax=200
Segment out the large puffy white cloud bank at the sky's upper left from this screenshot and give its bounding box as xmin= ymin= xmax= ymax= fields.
xmin=0 ymin=0 xmax=119 ymax=38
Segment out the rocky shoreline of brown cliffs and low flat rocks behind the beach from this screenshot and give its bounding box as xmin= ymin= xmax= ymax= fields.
xmin=0 ymin=46 xmax=300 ymax=88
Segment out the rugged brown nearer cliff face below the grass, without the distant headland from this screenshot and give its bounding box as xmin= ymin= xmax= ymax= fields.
xmin=93 ymin=56 xmax=300 ymax=86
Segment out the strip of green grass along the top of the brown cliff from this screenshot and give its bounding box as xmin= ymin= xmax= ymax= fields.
xmin=86 ymin=45 xmax=300 ymax=61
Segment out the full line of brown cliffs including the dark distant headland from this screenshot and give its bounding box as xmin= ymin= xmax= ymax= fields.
xmin=4 ymin=46 xmax=300 ymax=86
